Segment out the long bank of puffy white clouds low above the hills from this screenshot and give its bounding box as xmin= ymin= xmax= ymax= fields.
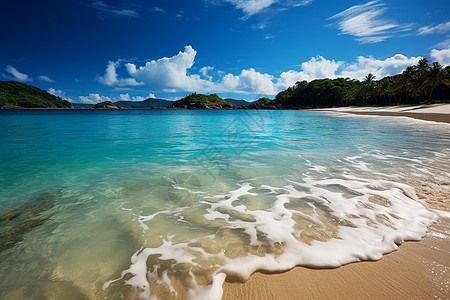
xmin=99 ymin=46 xmax=442 ymax=96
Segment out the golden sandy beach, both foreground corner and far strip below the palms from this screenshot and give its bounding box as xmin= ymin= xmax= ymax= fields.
xmin=223 ymin=104 xmax=450 ymax=299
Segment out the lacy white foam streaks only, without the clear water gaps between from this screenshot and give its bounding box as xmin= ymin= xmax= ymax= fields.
xmin=104 ymin=170 xmax=436 ymax=299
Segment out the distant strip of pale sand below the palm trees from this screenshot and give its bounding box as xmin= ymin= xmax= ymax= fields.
xmin=314 ymin=104 xmax=450 ymax=123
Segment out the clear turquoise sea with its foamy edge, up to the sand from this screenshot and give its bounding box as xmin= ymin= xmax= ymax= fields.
xmin=0 ymin=110 xmax=450 ymax=299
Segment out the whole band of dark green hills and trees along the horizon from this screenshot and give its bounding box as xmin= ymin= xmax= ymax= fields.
xmin=0 ymin=58 xmax=450 ymax=109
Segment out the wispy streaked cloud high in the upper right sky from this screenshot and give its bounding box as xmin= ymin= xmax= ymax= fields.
xmin=328 ymin=0 xmax=411 ymax=44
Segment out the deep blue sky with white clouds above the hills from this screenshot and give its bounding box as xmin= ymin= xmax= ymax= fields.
xmin=0 ymin=0 xmax=450 ymax=103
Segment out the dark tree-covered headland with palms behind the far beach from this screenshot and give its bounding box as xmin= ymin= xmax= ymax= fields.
xmin=273 ymin=58 xmax=450 ymax=108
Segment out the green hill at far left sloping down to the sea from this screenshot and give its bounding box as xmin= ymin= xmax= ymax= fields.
xmin=0 ymin=81 xmax=72 ymax=108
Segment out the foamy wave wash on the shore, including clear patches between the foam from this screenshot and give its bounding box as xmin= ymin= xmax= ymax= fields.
xmin=103 ymin=157 xmax=437 ymax=299
